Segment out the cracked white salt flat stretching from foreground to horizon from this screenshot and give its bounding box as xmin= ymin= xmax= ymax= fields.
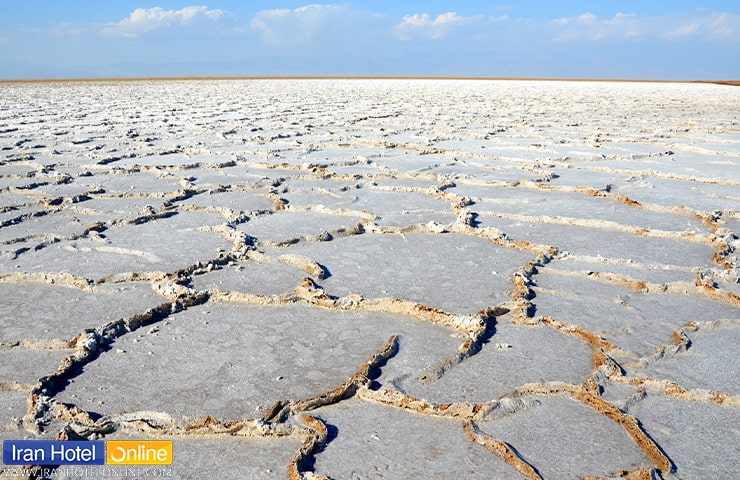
xmin=0 ymin=80 xmax=740 ymax=479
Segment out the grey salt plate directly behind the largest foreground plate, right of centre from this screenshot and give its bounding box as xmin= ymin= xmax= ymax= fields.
xmin=285 ymin=233 xmax=534 ymax=313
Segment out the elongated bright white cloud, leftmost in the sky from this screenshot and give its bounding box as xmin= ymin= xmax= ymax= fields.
xmin=100 ymin=6 xmax=227 ymax=38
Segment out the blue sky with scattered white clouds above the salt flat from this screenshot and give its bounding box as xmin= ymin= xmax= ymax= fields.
xmin=0 ymin=0 xmax=740 ymax=79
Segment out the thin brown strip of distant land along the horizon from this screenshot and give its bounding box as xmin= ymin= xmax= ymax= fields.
xmin=0 ymin=75 xmax=740 ymax=86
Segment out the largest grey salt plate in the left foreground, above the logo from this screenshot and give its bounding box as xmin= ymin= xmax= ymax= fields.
xmin=57 ymin=303 xmax=459 ymax=419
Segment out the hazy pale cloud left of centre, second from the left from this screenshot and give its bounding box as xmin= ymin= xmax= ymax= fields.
xmin=250 ymin=4 xmax=360 ymax=46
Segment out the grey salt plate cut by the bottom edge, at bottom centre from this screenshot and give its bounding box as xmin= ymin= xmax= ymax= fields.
xmin=312 ymin=400 xmax=526 ymax=480
